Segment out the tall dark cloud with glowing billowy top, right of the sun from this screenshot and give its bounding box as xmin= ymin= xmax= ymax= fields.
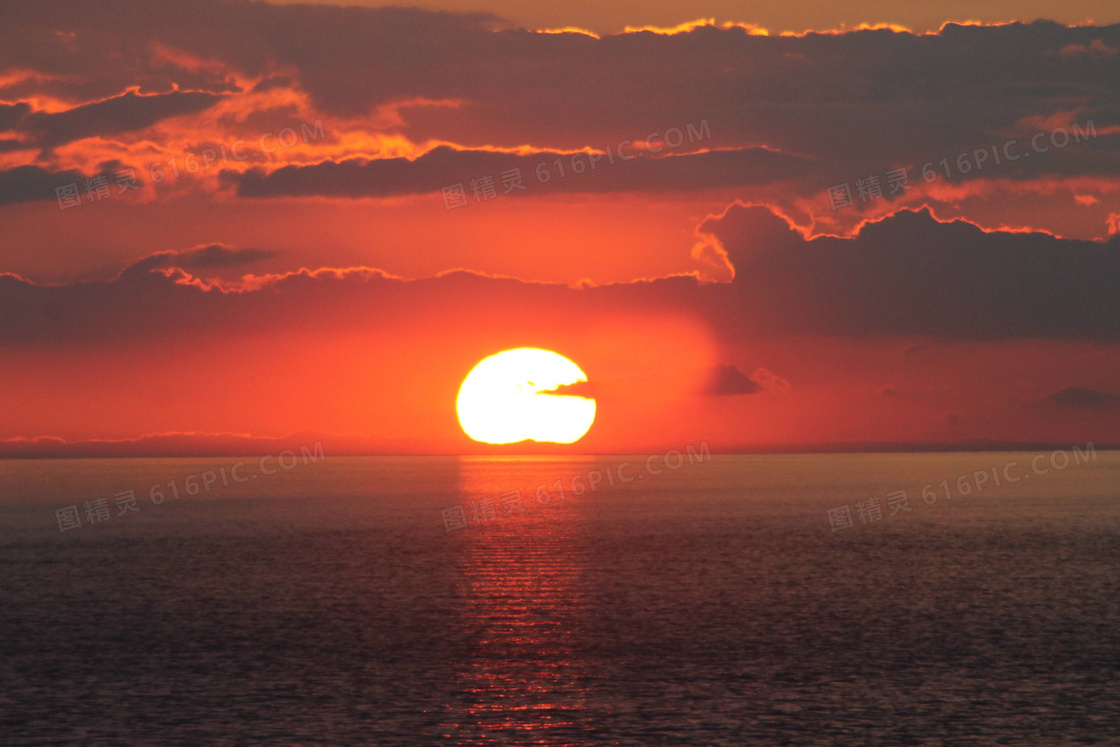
xmin=701 ymin=205 xmax=1120 ymax=342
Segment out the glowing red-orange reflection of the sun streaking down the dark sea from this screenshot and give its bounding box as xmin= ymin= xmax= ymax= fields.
xmin=444 ymin=459 xmax=590 ymax=745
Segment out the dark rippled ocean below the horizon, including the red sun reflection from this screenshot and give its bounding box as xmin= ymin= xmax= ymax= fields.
xmin=0 ymin=450 xmax=1120 ymax=747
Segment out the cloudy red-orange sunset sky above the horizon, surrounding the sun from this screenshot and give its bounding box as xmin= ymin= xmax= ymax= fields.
xmin=0 ymin=0 xmax=1120 ymax=456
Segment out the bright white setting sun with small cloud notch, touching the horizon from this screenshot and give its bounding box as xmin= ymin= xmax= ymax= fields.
xmin=456 ymin=347 xmax=595 ymax=443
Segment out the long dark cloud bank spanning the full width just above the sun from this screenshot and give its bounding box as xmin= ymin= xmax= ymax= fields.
xmin=0 ymin=206 xmax=1120 ymax=344
